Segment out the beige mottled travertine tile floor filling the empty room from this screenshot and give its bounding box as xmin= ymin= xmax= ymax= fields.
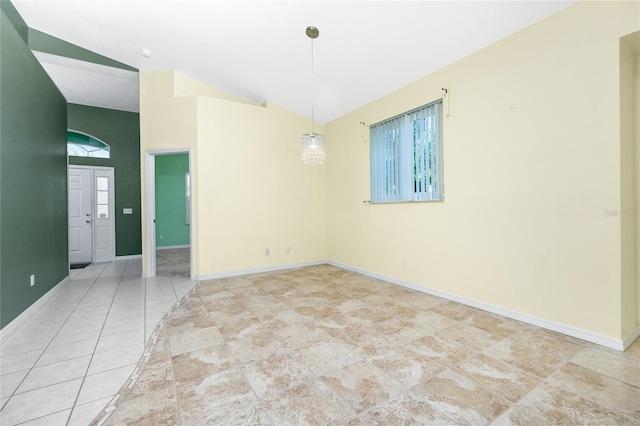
xmin=94 ymin=265 xmax=640 ymax=425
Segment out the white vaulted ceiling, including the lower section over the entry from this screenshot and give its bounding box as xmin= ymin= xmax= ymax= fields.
xmin=12 ymin=0 xmax=576 ymax=123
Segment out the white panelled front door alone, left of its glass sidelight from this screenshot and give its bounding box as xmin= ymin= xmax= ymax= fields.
xmin=69 ymin=168 xmax=93 ymax=264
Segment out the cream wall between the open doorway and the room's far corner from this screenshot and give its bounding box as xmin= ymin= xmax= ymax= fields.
xmin=196 ymin=97 xmax=326 ymax=275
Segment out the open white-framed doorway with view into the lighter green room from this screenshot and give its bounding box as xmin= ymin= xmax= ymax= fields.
xmin=144 ymin=149 xmax=194 ymax=278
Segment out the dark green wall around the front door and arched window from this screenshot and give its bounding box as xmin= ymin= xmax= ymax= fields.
xmin=65 ymin=104 xmax=142 ymax=256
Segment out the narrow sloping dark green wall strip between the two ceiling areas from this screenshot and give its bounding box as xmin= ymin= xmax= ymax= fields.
xmin=28 ymin=28 xmax=138 ymax=71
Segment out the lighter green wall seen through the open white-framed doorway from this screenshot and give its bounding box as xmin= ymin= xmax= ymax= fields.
xmin=155 ymin=154 xmax=190 ymax=247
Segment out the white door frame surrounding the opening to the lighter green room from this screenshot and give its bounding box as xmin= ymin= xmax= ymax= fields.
xmin=144 ymin=148 xmax=194 ymax=279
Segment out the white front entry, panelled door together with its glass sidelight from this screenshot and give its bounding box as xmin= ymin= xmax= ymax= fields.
xmin=68 ymin=166 xmax=116 ymax=267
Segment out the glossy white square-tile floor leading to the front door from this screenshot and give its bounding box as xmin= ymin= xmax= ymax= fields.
xmin=0 ymin=259 xmax=195 ymax=426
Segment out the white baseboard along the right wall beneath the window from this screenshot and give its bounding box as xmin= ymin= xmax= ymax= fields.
xmin=327 ymin=261 xmax=628 ymax=352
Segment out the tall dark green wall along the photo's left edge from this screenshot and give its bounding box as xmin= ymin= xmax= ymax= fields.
xmin=0 ymin=6 xmax=69 ymax=328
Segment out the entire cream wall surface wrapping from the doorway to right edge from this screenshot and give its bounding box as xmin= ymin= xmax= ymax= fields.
xmin=141 ymin=2 xmax=640 ymax=339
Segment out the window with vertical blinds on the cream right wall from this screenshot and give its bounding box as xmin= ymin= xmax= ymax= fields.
xmin=370 ymin=100 xmax=444 ymax=203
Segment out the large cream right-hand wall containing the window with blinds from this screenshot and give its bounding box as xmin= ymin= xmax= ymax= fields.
xmin=326 ymin=2 xmax=640 ymax=339
